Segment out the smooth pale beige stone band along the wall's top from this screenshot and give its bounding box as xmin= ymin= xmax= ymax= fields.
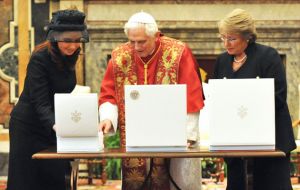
xmin=87 ymin=4 xmax=300 ymax=21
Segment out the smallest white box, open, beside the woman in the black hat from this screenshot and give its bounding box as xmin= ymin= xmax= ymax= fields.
xmin=54 ymin=93 xmax=103 ymax=153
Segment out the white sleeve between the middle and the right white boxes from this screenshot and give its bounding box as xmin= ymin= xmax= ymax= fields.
xmin=186 ymin=112 xmax=199 ymax=141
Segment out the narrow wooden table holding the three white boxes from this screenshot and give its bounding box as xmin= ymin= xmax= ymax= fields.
xmin=32 ymin=147 xmax=285 ymax=190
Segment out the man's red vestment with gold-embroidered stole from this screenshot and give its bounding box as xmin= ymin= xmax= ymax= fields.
xmin=99 ymin=37 xmax=204 ymax=190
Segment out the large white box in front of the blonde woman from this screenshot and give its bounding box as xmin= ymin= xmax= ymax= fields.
xmin=209 ymin=79 xmax=275 ymax=150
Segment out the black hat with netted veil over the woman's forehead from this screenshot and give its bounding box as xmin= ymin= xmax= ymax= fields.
xmin=47 ymin=10 xmax=89 ymax=42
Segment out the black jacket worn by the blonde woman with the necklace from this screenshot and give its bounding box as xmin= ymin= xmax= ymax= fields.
xmin=214 ymin=43 xmax=296 ymax=153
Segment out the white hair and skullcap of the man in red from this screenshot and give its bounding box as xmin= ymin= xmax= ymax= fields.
xmin=124 ymin=11 xmax=158 ymax=37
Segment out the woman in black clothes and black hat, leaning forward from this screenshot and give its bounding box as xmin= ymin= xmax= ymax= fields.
xmin=7 ymin=10 xmax=89 ymax=190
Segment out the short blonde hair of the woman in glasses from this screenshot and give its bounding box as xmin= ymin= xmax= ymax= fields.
xmin=218 ymin=9 xmax=257 ymax=43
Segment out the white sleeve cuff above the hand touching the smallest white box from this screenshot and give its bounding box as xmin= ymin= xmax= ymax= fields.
xmin=99 ymin=102 xmax=118 ymax=132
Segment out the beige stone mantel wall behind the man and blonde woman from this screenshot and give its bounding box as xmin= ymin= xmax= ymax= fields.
xmin=84 ymin=1 xmax=300 ymax=119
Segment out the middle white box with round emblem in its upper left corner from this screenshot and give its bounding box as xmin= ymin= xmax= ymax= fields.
xmin=125 ymin=85 xmax=187 ymax=151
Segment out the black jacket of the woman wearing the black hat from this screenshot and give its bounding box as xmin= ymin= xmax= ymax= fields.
xmin=11 ymin=48 xmax=76 ymax=137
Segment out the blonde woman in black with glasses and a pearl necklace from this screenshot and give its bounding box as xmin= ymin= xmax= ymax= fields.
xmin=214 ymin=9 xmax=296 ymax=190
